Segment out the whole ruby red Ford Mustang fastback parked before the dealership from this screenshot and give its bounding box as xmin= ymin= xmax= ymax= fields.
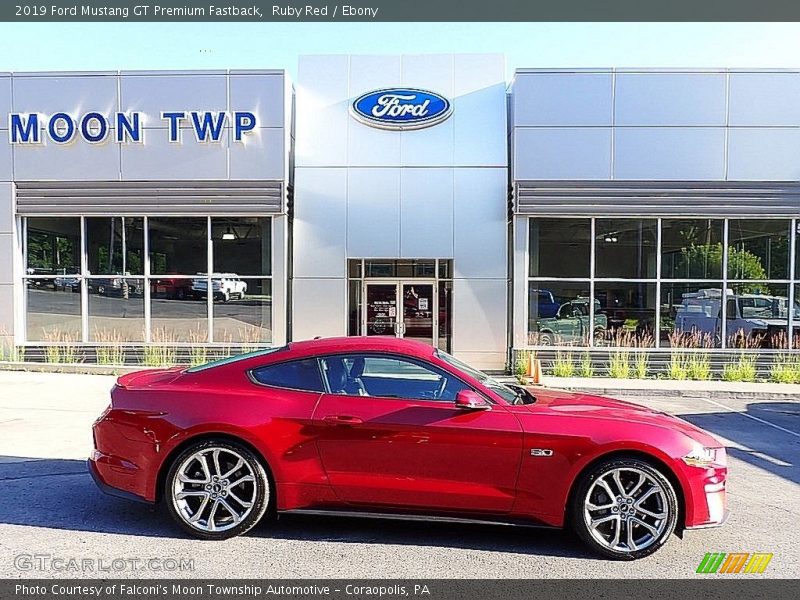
xmin=89 ymin=337 xmax=727 ymax=559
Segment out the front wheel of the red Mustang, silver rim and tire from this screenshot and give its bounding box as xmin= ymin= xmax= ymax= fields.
xmin=570 ymin=458 xmax=678 ymax=560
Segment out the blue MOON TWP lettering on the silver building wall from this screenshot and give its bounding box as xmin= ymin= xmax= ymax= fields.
xmin=8 ymin=110 xmax=257 ymax=145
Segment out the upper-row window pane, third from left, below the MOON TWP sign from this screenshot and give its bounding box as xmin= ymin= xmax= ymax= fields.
xmin=148 ymin=217 xmax=208 ymax=275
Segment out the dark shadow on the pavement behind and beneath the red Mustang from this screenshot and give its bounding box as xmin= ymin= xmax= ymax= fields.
xmin=0 ymin=456 xmax=593 ymax=558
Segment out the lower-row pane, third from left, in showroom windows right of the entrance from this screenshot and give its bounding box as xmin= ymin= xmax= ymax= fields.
xmin=659 ymin=282 xmax=722 ymax=348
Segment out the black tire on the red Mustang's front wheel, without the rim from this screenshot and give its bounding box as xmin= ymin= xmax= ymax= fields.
xmin=569 ymin=457 xmax=680 ymax=560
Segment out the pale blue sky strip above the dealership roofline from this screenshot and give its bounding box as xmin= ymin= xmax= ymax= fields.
xmin=0 ymin=23 xmax=800 ymax=78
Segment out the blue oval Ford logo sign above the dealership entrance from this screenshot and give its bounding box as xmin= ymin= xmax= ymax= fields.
xmin=351 ymin=88 xmax=453 ymax=129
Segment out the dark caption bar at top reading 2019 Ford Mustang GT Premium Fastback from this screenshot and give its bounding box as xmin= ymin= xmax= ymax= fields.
xmin=0 ymin=0 xmax=800 ymax=23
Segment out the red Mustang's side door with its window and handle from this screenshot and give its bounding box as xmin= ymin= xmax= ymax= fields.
xmin=313 ymin=354 xmax=522 ymax=512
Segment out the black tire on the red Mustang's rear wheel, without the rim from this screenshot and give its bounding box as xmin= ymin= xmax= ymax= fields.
xmin=164 ymin=440 xmax=274 ymax=540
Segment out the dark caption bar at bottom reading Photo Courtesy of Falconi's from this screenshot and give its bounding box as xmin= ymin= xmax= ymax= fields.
xmin=0 ymin=580 xmax=797 ymax=600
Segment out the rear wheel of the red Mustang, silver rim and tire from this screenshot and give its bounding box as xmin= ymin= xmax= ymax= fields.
xmin=165 ymin=440 xmax=270 ymax=540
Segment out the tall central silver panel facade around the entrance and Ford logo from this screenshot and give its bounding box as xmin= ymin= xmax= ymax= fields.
xmin=292 ymin=54 xmax=507 ymax=368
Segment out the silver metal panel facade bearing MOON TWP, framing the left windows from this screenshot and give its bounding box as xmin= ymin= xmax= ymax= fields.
xmin=0 ymin=70 xmax=292 ymax=343
